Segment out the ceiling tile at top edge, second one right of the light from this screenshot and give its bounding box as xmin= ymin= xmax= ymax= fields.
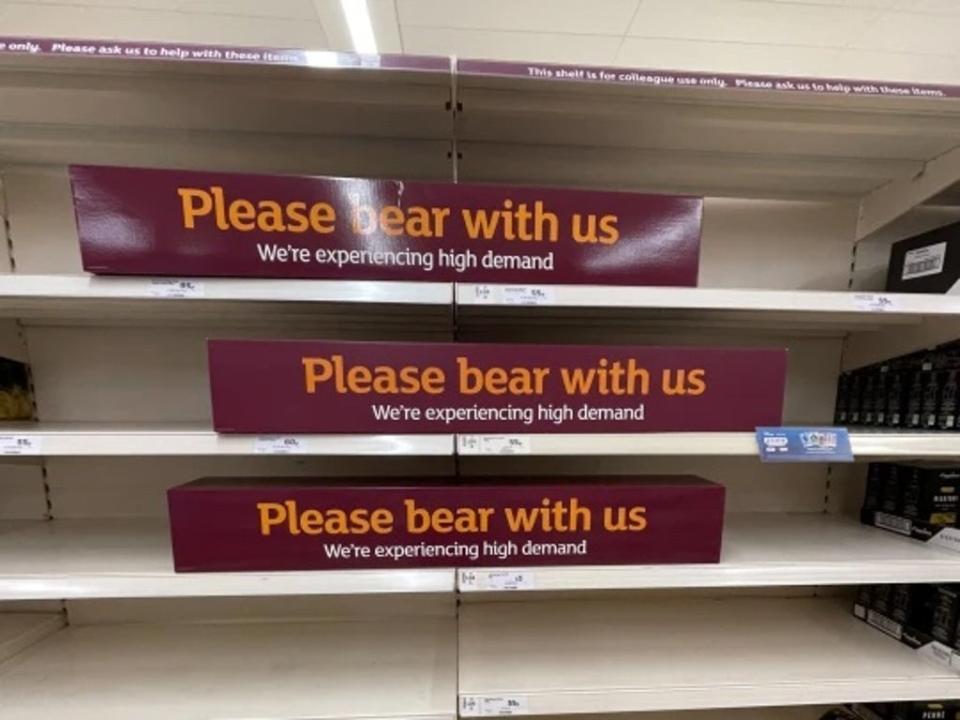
xmin=630 ymin=0 xmax=882 ymax=47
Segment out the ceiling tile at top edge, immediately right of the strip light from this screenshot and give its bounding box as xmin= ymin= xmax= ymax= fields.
xmin=397 ymin=0 xmax=638 ymax=35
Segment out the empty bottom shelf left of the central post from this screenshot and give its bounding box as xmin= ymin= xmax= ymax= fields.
xmin=0 ymin=617 xmax=456 ymax=720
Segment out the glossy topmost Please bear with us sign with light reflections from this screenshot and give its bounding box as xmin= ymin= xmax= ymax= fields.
xmin=70 ymin=167 xmax=703 ymax=286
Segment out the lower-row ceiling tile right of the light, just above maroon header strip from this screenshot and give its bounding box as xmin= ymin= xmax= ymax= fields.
xmin=402 ymin=26 xmax=620 ymax=64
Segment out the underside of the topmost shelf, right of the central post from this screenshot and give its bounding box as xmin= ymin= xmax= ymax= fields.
xmin=457 ymin=60 xmax=960 ymax=198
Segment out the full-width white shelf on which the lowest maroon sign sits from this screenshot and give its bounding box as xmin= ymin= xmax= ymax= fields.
xmin=0 ymin=513 xmax=960 ymax=600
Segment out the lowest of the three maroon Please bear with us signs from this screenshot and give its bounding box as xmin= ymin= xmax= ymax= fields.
xmin=167 ymin=476 xmax=724 ymax=572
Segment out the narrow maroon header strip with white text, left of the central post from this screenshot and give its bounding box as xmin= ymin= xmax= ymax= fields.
xmin=0 ymin=35 xmax=450 ymax=74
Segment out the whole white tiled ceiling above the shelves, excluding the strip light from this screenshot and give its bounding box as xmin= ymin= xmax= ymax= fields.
xmin=0 ymin=0 xmax=960 ymax=84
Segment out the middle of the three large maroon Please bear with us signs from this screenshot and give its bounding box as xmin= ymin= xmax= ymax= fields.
xmin=208 ymin=340 xmax=786 ymax=433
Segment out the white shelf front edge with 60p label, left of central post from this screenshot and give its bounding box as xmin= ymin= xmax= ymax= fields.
xmin=2 ymin=423 xmax=453 ymax=456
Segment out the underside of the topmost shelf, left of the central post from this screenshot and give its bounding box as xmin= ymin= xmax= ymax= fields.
xmin=0 ymin=41 xmax=450 ymax=178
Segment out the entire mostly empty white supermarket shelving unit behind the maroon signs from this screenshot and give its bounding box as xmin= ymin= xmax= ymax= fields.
xmin=0 ymin=35 xmax=960 ymax=720
